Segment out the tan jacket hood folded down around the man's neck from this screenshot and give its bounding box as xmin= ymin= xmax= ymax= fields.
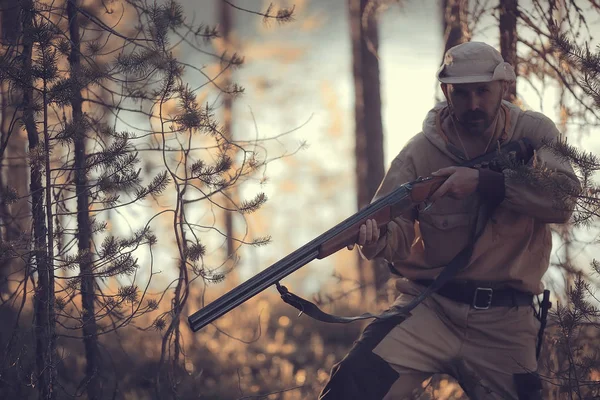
xmin=423 ymin=100 xmax=521 ymax=163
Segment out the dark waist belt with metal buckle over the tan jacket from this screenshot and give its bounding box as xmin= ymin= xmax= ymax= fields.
xmin=414 ymin=279 xmax=533 ymax=310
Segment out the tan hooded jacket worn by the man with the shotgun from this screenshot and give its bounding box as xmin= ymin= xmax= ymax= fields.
xmin=361 ymin=102 xmax=579 ymax=294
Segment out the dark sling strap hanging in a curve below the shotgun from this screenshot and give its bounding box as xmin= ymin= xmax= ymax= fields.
xmin=276 ymin=203 xmax=491 ymax=324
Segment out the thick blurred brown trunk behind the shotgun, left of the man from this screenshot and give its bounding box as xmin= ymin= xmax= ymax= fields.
xmin=349 ymin=0 xmax=389 ymax=296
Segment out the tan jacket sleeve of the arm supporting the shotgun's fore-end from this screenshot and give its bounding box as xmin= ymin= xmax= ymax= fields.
xmin=359 ymin=148 xmax=417 ymax=262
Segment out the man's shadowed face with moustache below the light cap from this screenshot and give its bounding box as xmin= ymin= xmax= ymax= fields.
xmin=442 ymin=81 xmax=504 ymax=135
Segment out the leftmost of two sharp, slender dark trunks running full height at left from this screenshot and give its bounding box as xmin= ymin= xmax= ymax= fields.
xmin=21 ymin=1 xmax=58 ymax=400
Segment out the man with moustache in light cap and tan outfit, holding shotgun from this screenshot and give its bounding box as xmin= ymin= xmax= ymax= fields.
xmin=320 ymin=42 xmax=579 ymax=400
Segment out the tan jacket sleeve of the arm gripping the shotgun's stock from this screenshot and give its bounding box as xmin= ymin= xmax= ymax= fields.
xmin=500 ymin=113 xmax=581 ymax=223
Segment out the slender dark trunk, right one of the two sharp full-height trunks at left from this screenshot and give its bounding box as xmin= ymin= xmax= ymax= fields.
xmin=67 ymin=0 xmax=102 ymax=400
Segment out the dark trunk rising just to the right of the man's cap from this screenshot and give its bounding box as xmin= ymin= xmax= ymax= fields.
xmin=499 ymin=0 xmax=519 ymax=103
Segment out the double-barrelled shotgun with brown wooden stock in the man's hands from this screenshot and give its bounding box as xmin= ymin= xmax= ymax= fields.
xmin=188 ymin=138 xmax=533 ymax=332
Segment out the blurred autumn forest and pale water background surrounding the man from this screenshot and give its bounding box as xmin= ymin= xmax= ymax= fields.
xmin=0 ymin=0 xmax=600 ymax=399
